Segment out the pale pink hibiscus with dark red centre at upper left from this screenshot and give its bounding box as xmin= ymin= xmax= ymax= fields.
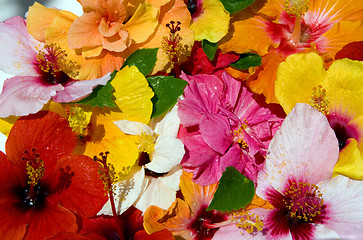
xmin=0 ymin=17 xmax=110 ymax=117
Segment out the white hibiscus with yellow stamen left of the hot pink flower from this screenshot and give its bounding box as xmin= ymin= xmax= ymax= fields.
xmin=100 ymin=108 xmax=184 ymax=215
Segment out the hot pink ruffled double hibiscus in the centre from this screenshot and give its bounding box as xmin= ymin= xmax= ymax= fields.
xmin=178 ymin=72 xmax=282 ymax=186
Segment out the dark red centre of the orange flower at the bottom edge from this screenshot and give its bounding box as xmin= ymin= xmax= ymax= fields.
xmin=190 ymin=208 xmax=227 ymax=240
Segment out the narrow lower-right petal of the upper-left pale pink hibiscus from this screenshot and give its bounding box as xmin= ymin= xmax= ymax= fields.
xmin=53 ymin=74 xmax=111 ymax=102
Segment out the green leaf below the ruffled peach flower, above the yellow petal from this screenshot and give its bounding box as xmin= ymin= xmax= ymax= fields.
xmin=122 ymin=48 xmax=158 ymax=76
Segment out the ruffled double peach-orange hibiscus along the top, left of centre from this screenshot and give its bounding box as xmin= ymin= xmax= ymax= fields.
xmin=28 ymin=0 xmax=194 ymax=79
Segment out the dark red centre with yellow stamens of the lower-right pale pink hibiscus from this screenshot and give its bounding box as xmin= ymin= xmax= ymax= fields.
xmin=265 ymin=180 xmax=327 ymax=239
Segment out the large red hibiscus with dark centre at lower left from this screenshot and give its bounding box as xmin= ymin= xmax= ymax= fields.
xmin=0 ymin=112 xmax=106 ymax=240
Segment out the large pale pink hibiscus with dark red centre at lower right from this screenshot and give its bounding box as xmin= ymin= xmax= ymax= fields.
xmin=256 ymin=103 xmax=363 ymax=239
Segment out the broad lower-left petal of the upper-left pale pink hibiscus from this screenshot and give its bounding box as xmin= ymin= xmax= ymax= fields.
xmin=0 ymin=76 xmax=63 ymax=117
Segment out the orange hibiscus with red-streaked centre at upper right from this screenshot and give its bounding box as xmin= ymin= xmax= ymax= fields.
xmin=220 ymin=0 xmax=363 ymax=103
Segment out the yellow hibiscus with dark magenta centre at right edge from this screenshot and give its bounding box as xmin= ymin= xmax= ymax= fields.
xmin=275 ymin=53 xmax=363 ymax=179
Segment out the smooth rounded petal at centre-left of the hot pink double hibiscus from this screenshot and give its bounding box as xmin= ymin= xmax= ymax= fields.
xmin=199 ymin=113 xmax=232 ymax=154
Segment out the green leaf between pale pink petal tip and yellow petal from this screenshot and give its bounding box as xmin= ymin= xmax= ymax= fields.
xmin=77 ymin=70 xmax=117 ymax=107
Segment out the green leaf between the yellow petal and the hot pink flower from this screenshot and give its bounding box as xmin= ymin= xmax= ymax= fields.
xmin=147 ymin=76 xmax=188 ymax=118
